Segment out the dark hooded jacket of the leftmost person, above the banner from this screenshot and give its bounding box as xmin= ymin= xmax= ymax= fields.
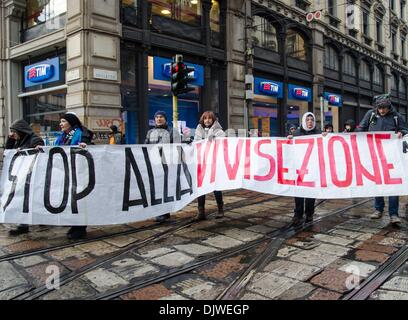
xmin=6 ymin=120 xmax=44 ymax=149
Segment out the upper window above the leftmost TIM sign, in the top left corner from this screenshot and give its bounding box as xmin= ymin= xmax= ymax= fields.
xmin=21 ymin=0 xmax=67 ymax=42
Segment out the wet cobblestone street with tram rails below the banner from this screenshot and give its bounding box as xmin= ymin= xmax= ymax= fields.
xmin=0 ymin=190 xmax=408 ymax=300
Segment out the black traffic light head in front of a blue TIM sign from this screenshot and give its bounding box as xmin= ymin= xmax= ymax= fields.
xmin=171 ymin=55 xmax=195 ymax=96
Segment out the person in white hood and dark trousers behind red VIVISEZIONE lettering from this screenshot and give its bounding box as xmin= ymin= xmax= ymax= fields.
xmin=288 ymin=112 xmax=321 ymax=226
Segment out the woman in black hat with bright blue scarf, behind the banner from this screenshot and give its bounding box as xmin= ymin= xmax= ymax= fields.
xmin=55 ymin=112 xmax=93 ymax=240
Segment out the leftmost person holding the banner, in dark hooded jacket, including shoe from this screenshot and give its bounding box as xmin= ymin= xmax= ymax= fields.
xmin=6 ymin=120 xmax=44 ymax=236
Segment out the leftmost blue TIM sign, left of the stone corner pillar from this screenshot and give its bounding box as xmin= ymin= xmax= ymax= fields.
xmin=24 ymin=58 xmax=60 ymax=88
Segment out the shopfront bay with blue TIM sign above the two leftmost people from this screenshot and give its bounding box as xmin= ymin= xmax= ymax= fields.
xmin=19 ymin=53 xmax=67 ymax=144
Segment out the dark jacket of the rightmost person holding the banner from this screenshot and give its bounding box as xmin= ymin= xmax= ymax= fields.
xmin=356 ymin=107 xmax=408 ymax=135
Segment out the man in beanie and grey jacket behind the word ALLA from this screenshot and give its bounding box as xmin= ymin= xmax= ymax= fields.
xmin=145 ymin=111 xmax=191 ymax=222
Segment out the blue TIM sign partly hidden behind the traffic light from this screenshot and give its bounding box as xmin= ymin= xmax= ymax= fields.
xmin=153 ymin=57 xmax=204 ymax=87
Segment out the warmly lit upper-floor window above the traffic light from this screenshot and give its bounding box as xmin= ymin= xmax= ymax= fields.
xmin=149 ymin=0 xmax=202 ymax=26
